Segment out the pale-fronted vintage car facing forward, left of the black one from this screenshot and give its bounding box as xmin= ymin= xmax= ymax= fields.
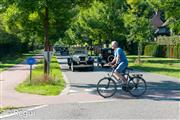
xmin=67 ymin=49 xmax=94 ymax=71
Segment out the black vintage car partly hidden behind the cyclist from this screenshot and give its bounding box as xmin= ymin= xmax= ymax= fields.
xmin=97 ymin=48 xmax=114 ymax=67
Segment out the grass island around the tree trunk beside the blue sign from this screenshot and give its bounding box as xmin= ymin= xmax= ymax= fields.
xmin=16 ymin=57 xmax=65 ymax=95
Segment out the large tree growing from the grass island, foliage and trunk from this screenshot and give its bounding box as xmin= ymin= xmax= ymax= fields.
xmin=2 ymin=0 xmax=91 ymax=74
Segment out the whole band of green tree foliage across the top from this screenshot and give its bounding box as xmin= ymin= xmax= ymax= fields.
xmin=0 ymin=0 xmax=180 ymax=54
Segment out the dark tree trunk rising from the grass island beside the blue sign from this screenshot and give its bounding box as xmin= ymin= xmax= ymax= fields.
xmin=44 ymin=7 xmax=49 ymax=76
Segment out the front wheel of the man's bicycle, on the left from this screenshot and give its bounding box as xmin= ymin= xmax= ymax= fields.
xmin=97 ymin=77 xmax=117 ymax=98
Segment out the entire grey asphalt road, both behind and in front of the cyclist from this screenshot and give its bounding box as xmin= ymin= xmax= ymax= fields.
xmin=1 ymin=55 xmax=180 ymax=120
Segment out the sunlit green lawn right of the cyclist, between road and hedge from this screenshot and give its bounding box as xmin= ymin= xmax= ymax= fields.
xmin=128 ymin=56 xmax=180 ymax=78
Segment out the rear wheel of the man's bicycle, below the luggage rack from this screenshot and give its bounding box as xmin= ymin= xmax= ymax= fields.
xmin=128 ymin=77 xmax=147 ymax=97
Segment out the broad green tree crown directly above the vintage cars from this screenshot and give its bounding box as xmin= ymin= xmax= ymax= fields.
xmin=62 ymin=0 xmax=126 ymax=48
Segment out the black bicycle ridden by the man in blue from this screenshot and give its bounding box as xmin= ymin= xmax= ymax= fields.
xmin=97 ymin=67 xmax=147 ymax=98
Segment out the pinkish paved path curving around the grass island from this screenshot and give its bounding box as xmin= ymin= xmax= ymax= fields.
xmin=0 ymin=56 xmax=103 ymax=107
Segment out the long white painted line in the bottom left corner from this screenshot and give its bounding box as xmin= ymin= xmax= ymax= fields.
xmin=0 ymin=105 xmax=47 ymax=119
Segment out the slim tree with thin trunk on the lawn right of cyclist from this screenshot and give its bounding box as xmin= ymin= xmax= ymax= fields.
xmin=124 ymin=0 xmax=152 ymax=63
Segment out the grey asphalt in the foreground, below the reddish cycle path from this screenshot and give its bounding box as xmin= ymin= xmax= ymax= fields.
xmin=2 ymin=100 xmax=180 ymax=120
